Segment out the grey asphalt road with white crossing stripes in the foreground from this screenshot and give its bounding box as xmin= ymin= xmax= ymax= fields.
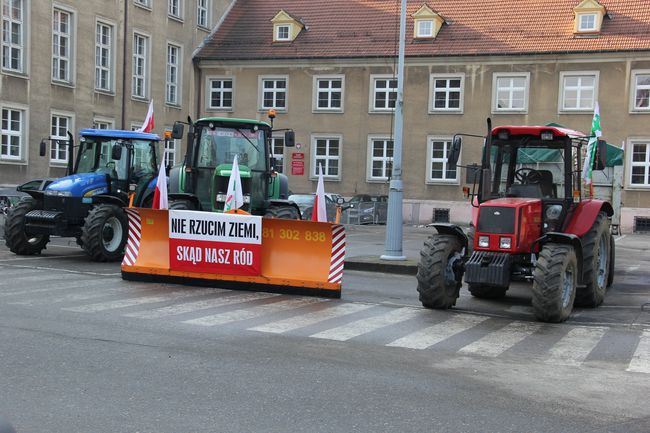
xmin=0 ymin=231 xmax=650 ymax=433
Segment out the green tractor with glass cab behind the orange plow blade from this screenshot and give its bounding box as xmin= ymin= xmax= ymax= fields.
xmin=168 ymin=113 xmax=300 ymax=219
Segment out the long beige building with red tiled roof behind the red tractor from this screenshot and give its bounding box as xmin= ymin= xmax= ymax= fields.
xmin=195 ymin=0 xmax=650 ymax=230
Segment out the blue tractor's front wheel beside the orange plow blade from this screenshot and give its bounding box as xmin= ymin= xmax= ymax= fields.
xmin=81 ymin=204 xmax=129 ymax=262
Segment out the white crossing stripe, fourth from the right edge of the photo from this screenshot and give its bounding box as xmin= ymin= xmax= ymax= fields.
xmin=386 ymin=315 xmax=489 ymax=349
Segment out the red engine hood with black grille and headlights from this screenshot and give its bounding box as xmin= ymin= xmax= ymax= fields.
xmin=474 ymin=197 xmax=542 ymax=254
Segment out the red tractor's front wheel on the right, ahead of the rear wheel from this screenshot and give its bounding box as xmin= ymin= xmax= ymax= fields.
xmin=533 ymin=244 xmax=578 ymax=323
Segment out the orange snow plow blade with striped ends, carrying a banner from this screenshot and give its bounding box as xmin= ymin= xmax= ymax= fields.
xmin=122 ymin=208 xmax=345 ymax=298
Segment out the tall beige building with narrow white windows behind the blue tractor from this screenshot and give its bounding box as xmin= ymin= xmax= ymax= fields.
xmin=0 ymin=0 xmax=231 ymax=185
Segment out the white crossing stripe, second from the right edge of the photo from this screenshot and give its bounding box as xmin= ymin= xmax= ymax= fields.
xmin=544 ymin=326 xmax=607 ymax=366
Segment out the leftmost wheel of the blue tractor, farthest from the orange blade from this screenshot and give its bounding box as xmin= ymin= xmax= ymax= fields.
xmin=5 ymin=197 xmax=50 ymax=256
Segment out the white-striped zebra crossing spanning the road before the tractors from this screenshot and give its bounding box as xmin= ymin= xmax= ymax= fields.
xmin=0 ymin=271 xmax=650 ymax=374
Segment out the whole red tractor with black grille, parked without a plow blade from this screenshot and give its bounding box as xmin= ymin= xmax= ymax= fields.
xmin=417 ymin=120 xmax=614 ymax=322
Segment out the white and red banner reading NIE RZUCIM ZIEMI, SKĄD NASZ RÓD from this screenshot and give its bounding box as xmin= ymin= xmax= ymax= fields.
xmin=169 ymin=210 xmax=262 ymax=276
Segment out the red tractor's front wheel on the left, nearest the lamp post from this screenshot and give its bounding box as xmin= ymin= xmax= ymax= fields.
xmin=416 ymin=235 xmax=463 ymax=309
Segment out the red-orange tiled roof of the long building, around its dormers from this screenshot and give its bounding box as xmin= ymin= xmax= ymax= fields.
xmin=196 ymin=0 xmax=650 ymax=60
